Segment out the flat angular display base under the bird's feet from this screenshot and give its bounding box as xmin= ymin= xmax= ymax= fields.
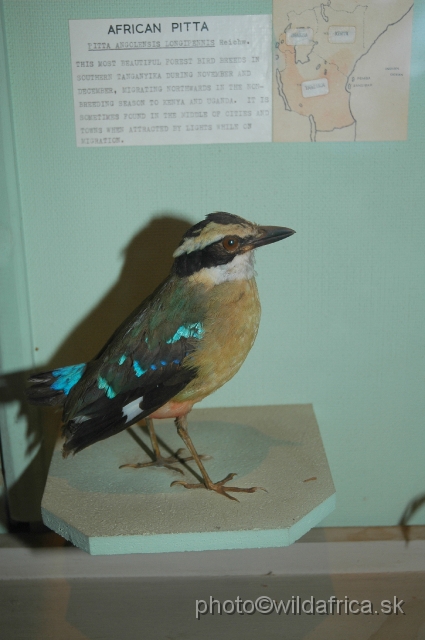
xmin=42 ymin=405 xmax=335 ymax=554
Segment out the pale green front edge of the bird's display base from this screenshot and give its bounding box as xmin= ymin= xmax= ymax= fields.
xmin=42 ymin=493 xmax=336 ymax=555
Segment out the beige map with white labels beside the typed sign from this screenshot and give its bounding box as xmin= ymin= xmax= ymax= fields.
xmin=273 ymin=0 xmax=413 ymax=142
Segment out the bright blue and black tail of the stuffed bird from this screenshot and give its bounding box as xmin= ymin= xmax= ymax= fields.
xmin=26 ymin=363 xmax=87 ymax=406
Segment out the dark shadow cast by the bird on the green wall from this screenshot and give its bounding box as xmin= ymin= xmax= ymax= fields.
xmin=0 ymin=212 xmax=192 ymax=520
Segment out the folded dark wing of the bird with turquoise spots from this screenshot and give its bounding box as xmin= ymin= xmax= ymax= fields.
xmin=29 ymin=275 xmax=206 ymax=455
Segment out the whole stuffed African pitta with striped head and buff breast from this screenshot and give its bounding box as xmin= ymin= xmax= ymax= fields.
xmin=27 ymin=212 xmax=295 ymax=500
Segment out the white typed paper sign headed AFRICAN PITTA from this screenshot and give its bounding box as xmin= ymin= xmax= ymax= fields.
xmin=69 ymin=15 xmax=272 ymax=147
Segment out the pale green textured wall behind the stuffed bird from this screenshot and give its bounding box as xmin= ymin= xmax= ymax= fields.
xmin=3 ymin=0 xmax=425 ymax=526
